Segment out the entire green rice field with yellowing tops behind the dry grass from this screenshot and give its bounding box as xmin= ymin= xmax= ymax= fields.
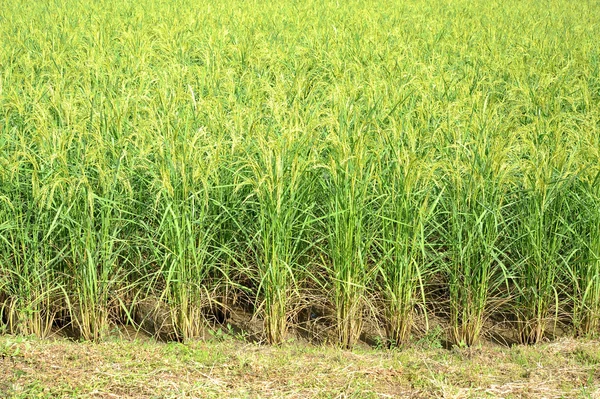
xmin=0 ymin=0 xmax=600 ymax=348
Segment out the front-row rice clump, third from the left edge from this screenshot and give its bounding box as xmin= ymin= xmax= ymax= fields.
xmin=148 ymin=126 xmax=229 ymax=340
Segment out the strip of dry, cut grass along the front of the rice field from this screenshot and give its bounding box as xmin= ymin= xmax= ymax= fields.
xmin=0 ymin=336 xmax=600 ymax=398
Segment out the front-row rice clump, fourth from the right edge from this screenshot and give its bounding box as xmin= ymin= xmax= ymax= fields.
xmin=377 ymin=136 xmax=439 ymax=345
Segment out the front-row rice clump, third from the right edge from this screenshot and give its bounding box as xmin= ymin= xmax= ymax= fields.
xmin=443 ymin=136 xmax=507 ymax=346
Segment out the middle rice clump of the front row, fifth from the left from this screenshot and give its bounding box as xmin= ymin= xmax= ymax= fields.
xmin=322 ymin=114 xmax=375 ymax=348
